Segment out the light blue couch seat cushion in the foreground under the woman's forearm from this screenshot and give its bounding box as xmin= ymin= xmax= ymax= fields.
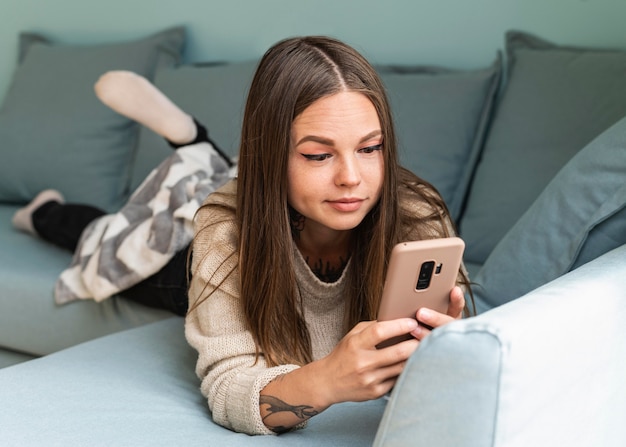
xmin=0 ymin=317 xmax=385 ymax=447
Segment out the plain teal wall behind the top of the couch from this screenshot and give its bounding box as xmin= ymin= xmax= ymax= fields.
xmin=0 ymin=0 xmax=626 ymax=98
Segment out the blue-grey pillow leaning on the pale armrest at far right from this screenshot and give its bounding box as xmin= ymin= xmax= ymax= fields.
xmin=473 ymin=114 xmax=626 ymax=311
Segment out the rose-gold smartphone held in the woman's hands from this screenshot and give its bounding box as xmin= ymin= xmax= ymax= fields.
xmin=378 ymin=237 xmax=465 ymax=347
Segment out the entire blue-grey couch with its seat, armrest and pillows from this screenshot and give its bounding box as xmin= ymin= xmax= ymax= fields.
xmin=0 ymin=27 xmax=626 ymax=446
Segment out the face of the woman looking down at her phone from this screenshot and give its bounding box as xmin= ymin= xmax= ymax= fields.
xmin=288 ymin=92 xmax=384 ymax=242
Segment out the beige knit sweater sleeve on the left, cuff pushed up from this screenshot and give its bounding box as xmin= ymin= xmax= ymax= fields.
xmin=185 ymin=181 xmax=297 ymax=434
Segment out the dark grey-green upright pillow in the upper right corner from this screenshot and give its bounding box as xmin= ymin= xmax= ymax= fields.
xmin=460 ymin=32 xmax=626 ymax=264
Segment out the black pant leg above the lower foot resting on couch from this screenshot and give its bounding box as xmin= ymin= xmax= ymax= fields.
xmin=32 ymin=202 xmax=106 ymax=252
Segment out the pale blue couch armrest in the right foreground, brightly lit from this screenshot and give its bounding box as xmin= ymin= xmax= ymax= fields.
xmin=374 ymin=245 xmax=626 ymax=447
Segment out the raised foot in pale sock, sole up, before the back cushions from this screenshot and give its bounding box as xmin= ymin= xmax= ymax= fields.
xmin=94 ymin=71 xmax=196 ymax=145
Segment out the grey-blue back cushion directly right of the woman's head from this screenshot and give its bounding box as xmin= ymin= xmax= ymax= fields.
xmin=376 ymin=54 xmax=502 ymax=220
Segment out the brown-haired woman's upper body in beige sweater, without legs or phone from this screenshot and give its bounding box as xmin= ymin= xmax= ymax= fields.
xmin=186 ymin=37 xmax=467 ymax=434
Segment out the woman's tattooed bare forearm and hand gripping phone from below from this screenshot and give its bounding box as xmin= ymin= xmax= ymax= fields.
xmin=260 ymin=318 xmax=419 ymax=433
